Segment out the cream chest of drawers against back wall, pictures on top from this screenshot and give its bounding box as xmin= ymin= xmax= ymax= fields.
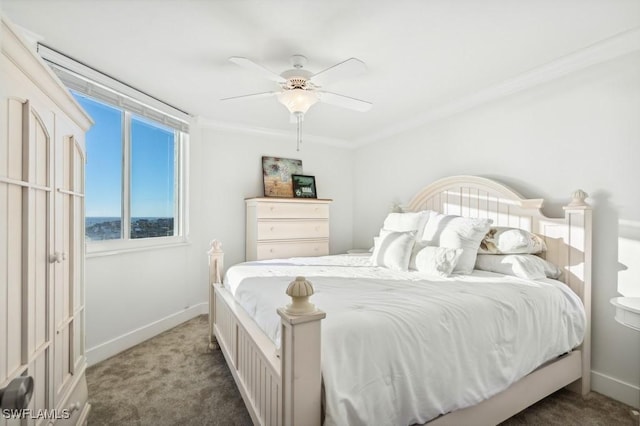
xmin=245 ymin=198 xmax=332 ymax=260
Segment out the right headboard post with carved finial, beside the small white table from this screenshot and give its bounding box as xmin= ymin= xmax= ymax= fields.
xmin=563 ymin=189 xmax=592 ymax=395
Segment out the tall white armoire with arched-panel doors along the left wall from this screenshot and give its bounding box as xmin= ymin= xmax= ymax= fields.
xmin=0 ymin=17 xmax=92 ymax=425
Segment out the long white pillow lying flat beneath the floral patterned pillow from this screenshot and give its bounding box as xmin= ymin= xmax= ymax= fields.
xmin=476 ymin=254 xmax=562 ymax=280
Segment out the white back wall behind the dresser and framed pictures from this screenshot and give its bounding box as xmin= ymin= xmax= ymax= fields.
xmin=199 ymin=127 xmax=353 ymax=274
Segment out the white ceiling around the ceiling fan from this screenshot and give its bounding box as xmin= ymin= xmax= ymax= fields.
xmin=0 ymin=0 xmax=640 ymax=144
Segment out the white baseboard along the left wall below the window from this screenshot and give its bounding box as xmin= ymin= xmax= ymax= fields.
xmin=87 ymin=302 xmax=209 ymax=366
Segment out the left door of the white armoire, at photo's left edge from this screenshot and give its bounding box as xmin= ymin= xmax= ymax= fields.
xmin=0 ymin=98 xmax=53 ymax=424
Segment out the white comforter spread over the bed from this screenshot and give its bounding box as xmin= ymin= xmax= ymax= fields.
xmin=225 ymin=255 xmax=585 ymax=426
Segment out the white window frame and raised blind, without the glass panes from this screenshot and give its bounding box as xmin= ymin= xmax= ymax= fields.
xmin=38 ymin=45 xmax=191 ymax=257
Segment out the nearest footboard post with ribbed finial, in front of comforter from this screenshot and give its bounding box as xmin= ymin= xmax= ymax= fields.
xmin=278 ymin=277 xmax=326 ymax=426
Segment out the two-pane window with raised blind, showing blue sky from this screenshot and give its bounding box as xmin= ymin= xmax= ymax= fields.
xmin=39 ymin=46 xmax=188 ymax=252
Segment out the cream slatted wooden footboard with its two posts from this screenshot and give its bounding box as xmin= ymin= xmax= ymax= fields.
xmin=209 ymin=241 xmax=326 ymax=426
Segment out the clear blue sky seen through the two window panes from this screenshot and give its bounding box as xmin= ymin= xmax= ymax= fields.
xmin=73 ymin=93 xmax=175 ymax=218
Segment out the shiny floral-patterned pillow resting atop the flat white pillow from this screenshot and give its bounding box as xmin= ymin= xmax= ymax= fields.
xmin=478 ymin=226 xmax=547 ymax=254
